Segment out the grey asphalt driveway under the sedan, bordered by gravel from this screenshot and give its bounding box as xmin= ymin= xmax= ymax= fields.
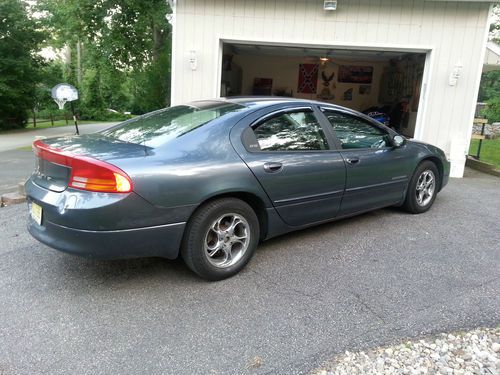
xmin=0 ymin=171 xmax=500 ymax=374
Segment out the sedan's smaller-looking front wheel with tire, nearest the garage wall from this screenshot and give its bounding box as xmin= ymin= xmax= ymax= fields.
xmin=403 ymin=161 xmax=440 ymax=214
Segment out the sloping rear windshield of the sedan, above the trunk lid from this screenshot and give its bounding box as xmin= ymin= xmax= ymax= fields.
xmin=103 ymin=102 xmax=245 ymax=147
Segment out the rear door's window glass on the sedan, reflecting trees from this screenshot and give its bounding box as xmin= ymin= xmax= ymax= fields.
xmin=254 ymin=110 xmax=328 ymax=151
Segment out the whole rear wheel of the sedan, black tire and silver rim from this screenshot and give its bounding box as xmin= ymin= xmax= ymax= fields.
xmin=181 ymin=198 xmax=260 ymax=281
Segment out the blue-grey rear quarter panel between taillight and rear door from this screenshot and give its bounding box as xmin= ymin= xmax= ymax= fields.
xmin=113 ymin=121 xmax=270 ymax=216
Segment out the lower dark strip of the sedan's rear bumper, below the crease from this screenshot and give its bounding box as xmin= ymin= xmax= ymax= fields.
xmin=28 ymin=213 xmax=186 ymax=259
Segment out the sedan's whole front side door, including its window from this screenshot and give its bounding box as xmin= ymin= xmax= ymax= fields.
xmin=322 ymin=108 xmax=411 ymax=215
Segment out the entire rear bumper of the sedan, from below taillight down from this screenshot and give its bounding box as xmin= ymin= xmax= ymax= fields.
xmin=25 ymin=179 xmax=193 ymax=259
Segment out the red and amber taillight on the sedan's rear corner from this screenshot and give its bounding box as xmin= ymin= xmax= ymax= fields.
xmin=33 ymin=140 xmax=132 ymax=193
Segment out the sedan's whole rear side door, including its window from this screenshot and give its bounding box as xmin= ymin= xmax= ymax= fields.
xmin=235 ymin=107 xmax=345 ymax=226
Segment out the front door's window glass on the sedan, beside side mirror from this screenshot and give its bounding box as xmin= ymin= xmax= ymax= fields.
xmin=324 ymin=110 xmax=390 ymax=149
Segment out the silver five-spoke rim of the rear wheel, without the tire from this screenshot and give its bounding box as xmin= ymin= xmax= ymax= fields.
xmin=204 ymin=213 xmax=250 ymax=268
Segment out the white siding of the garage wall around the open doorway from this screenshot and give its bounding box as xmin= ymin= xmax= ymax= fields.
xmin=172 ymin=0 xmax=490 ymax=177
